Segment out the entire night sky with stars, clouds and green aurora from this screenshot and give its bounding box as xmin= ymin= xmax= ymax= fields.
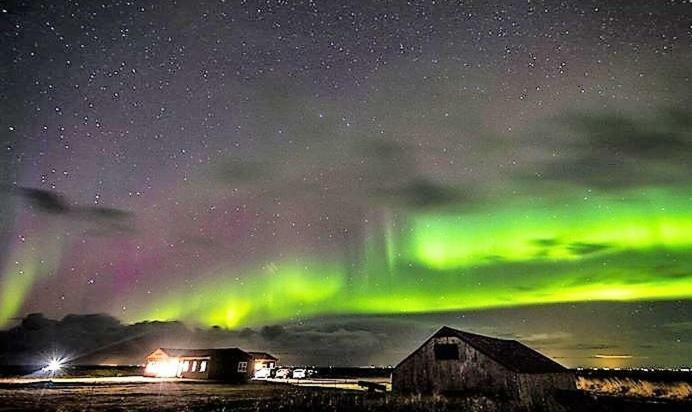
xmin=0 ymin=0 xmax=692 ymax=366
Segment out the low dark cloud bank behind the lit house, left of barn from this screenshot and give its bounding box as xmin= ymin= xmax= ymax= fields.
xmin=0 ymin=314 xmax=392 ymax=365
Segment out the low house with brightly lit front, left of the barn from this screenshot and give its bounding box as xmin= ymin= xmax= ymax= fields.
xmin=144 ymin=348 xmax=277 ymax=382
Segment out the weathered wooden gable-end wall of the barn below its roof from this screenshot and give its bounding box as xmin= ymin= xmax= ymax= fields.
xmin=392 ymin=336 xmax=513 ymax=395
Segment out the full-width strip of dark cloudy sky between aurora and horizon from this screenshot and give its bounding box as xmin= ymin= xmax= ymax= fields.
xmin=0 ymin=301 xmax=692 ymax=366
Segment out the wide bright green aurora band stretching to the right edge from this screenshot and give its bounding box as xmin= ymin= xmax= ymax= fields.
xmin=135 ymin=187 xmax=692 ymax=328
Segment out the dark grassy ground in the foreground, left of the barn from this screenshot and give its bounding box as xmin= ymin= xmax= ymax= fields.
xmin=0 ymin=377 xmax=524 ymax=412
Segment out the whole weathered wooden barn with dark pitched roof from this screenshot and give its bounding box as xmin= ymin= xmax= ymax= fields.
xmin=392 ymin=326 xmax=576 ymax=408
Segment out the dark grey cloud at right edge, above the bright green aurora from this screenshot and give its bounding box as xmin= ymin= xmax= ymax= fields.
xmin=539 ymin=109 xmax=692 ymax=188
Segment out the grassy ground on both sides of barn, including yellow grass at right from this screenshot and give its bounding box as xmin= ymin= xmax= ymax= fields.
xmin=0 ymin=370 xmax=692 ymax=412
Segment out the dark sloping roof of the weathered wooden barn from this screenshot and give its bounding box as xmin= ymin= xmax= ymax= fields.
xmin=399 ymin=326 xmax=567 ymax=373
